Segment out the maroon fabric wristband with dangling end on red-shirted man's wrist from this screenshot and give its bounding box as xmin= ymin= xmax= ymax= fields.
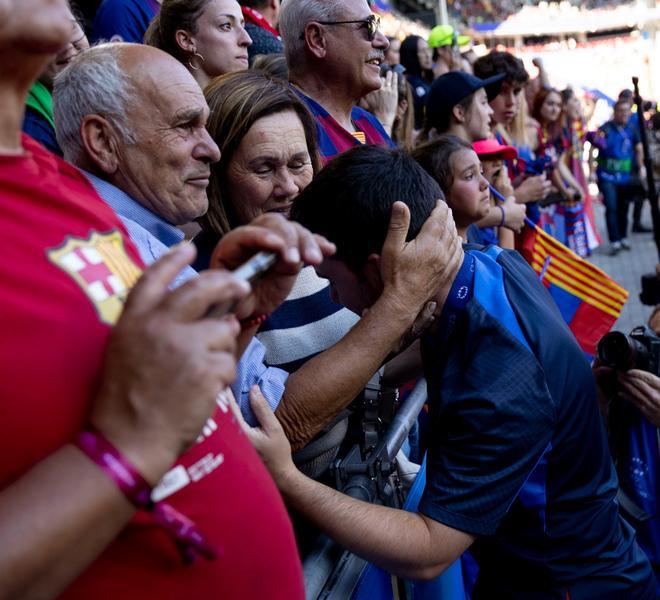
xmin=75 ymin=431 xmax=218 ymax=564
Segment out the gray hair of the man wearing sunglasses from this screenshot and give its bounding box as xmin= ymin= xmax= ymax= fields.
xmin=279 ymin=0 xmax=346 ymax=69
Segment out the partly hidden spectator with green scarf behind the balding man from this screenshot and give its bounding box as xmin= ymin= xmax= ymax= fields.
xmin=23 ymin=4 xmax=89 ymax=156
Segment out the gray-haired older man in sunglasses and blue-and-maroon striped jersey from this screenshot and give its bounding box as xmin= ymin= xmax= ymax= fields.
xmin=280 ymin=0 xmax=393 ymax=162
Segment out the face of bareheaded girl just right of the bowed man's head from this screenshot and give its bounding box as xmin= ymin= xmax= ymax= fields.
xmin=447 ymin=149 xmax=490 ymax=227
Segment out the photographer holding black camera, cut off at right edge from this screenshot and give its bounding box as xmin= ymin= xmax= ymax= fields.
xmin=594 ymin=322 xmax=660 ymax=597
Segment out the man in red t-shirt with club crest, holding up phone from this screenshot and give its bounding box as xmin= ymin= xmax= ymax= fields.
xmin=0 ymin=0 xmax=331 ymax=599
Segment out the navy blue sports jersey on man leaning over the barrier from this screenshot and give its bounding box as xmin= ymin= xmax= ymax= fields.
xmin=419 ymin=246 xmax=655 ymax=600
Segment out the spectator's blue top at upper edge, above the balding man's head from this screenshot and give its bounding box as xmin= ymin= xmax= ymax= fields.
xmin=92 ymin=0 xmax=161 ymax=44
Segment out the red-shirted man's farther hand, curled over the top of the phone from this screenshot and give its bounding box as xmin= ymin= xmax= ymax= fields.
xmin=211 ymin=213 xmax=335 ymax=319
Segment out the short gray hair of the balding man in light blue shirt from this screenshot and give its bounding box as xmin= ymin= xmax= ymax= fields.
xmin=53 ymin=44 xmax=136 ymax=163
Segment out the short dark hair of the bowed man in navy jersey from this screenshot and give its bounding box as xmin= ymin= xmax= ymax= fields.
xmin=291 ymin=146 xmax=444 ymax=273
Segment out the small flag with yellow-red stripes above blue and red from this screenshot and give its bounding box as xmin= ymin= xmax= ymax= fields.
xmin=518 ymin=222 xmax=628 ymax=356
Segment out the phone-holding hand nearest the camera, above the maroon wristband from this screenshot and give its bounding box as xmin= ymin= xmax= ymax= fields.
xmin=90 ymin=244 xmax=249 ymax=484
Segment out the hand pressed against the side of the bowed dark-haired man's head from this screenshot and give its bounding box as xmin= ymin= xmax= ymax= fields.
xmin=380 ymin=201 xmax=463 ymax=315
